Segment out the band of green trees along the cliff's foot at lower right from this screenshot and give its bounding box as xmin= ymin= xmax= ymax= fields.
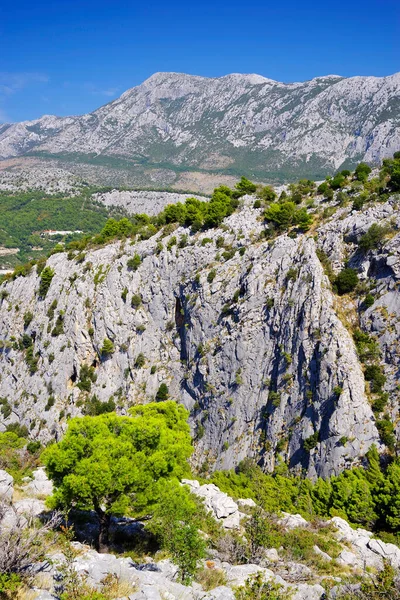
xmin=209 ymin=450 xmax=400 ymax=536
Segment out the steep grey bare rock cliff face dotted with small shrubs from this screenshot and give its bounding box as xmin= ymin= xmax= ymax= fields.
xmin=0 ymin=197 xmax=400 ymax=477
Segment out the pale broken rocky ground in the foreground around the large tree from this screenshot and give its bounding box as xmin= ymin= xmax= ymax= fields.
xmin=0 ymin=468 xmax=400 ymax=600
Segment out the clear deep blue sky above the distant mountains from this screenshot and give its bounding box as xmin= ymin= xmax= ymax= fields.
xmin=0 ymin=0 xmax=400 ymax=122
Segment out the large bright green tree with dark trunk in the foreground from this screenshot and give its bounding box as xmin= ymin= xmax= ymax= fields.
xmin=43 ymin=401 xmax=192 ymax=550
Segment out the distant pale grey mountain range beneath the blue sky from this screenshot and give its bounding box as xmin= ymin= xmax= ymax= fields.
xmin=0 ymin=73 xmax=400 ymax=189
